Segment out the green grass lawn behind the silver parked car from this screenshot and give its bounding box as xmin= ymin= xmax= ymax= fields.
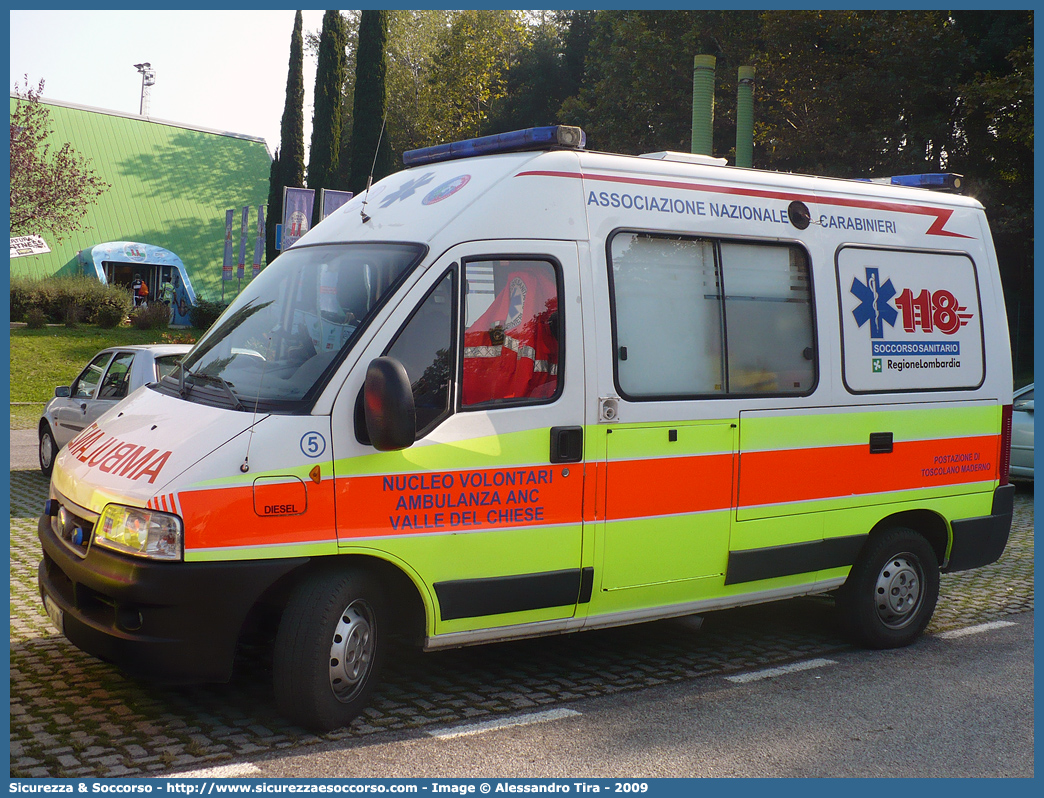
xmin=10 ymin=324 xmax=199 ymax=429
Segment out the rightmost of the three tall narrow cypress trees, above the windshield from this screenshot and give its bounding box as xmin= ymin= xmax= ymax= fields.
xmin=347 ymin=10 xmax=392 ymax=193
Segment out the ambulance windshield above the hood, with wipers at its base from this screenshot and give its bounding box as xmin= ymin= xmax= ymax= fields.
xmin=160 ymin=243 xmax=425 ymax=413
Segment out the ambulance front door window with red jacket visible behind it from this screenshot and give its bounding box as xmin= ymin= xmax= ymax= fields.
xmin=461 ymin=260 xmax=563 ymax=408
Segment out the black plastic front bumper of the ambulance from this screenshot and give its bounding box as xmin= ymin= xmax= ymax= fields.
xmin=38 ymin=515 xmax=308 ymax=682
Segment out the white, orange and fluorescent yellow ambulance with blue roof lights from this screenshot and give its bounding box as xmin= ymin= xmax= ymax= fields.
xmin=39 ymin=126 xmax=1014 ymax=730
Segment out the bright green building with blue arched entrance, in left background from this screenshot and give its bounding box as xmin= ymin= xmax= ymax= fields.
xmin=10 ymin=97 xmax=271 ymax=309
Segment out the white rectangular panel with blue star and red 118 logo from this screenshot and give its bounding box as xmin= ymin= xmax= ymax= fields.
xmin=837 ymin=247 xmax=986 ymax=393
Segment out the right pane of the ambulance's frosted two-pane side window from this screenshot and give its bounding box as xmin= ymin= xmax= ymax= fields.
xmin=721 ymin=242 xmax=815 ymax=396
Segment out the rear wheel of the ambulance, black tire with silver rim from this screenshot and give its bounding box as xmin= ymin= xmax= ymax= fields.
xmin=836 ymin=527 xmax=939 ymax=649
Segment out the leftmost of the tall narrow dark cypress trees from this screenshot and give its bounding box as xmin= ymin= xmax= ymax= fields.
xmin=265 ymin=10 xmax=305 ymax=263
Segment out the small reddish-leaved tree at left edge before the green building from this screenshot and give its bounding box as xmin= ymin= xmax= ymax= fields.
xmin=10 ymin=75 xmax=111 ymax=241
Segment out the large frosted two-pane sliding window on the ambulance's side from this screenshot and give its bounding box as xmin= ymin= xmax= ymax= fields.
xmin=609 ymin=232 xmax=816 ymax=400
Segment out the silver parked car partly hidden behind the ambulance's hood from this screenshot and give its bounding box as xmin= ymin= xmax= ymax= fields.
xmin=39 ymin=344 xmax=192 ymax=476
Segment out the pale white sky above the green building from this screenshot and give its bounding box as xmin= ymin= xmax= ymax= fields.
xmin=8 ymin=10 xmax=323 ymax=155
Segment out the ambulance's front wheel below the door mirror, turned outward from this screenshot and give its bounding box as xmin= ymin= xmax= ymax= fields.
xmin=272 ymin=570 xmax=388 ymax=732
